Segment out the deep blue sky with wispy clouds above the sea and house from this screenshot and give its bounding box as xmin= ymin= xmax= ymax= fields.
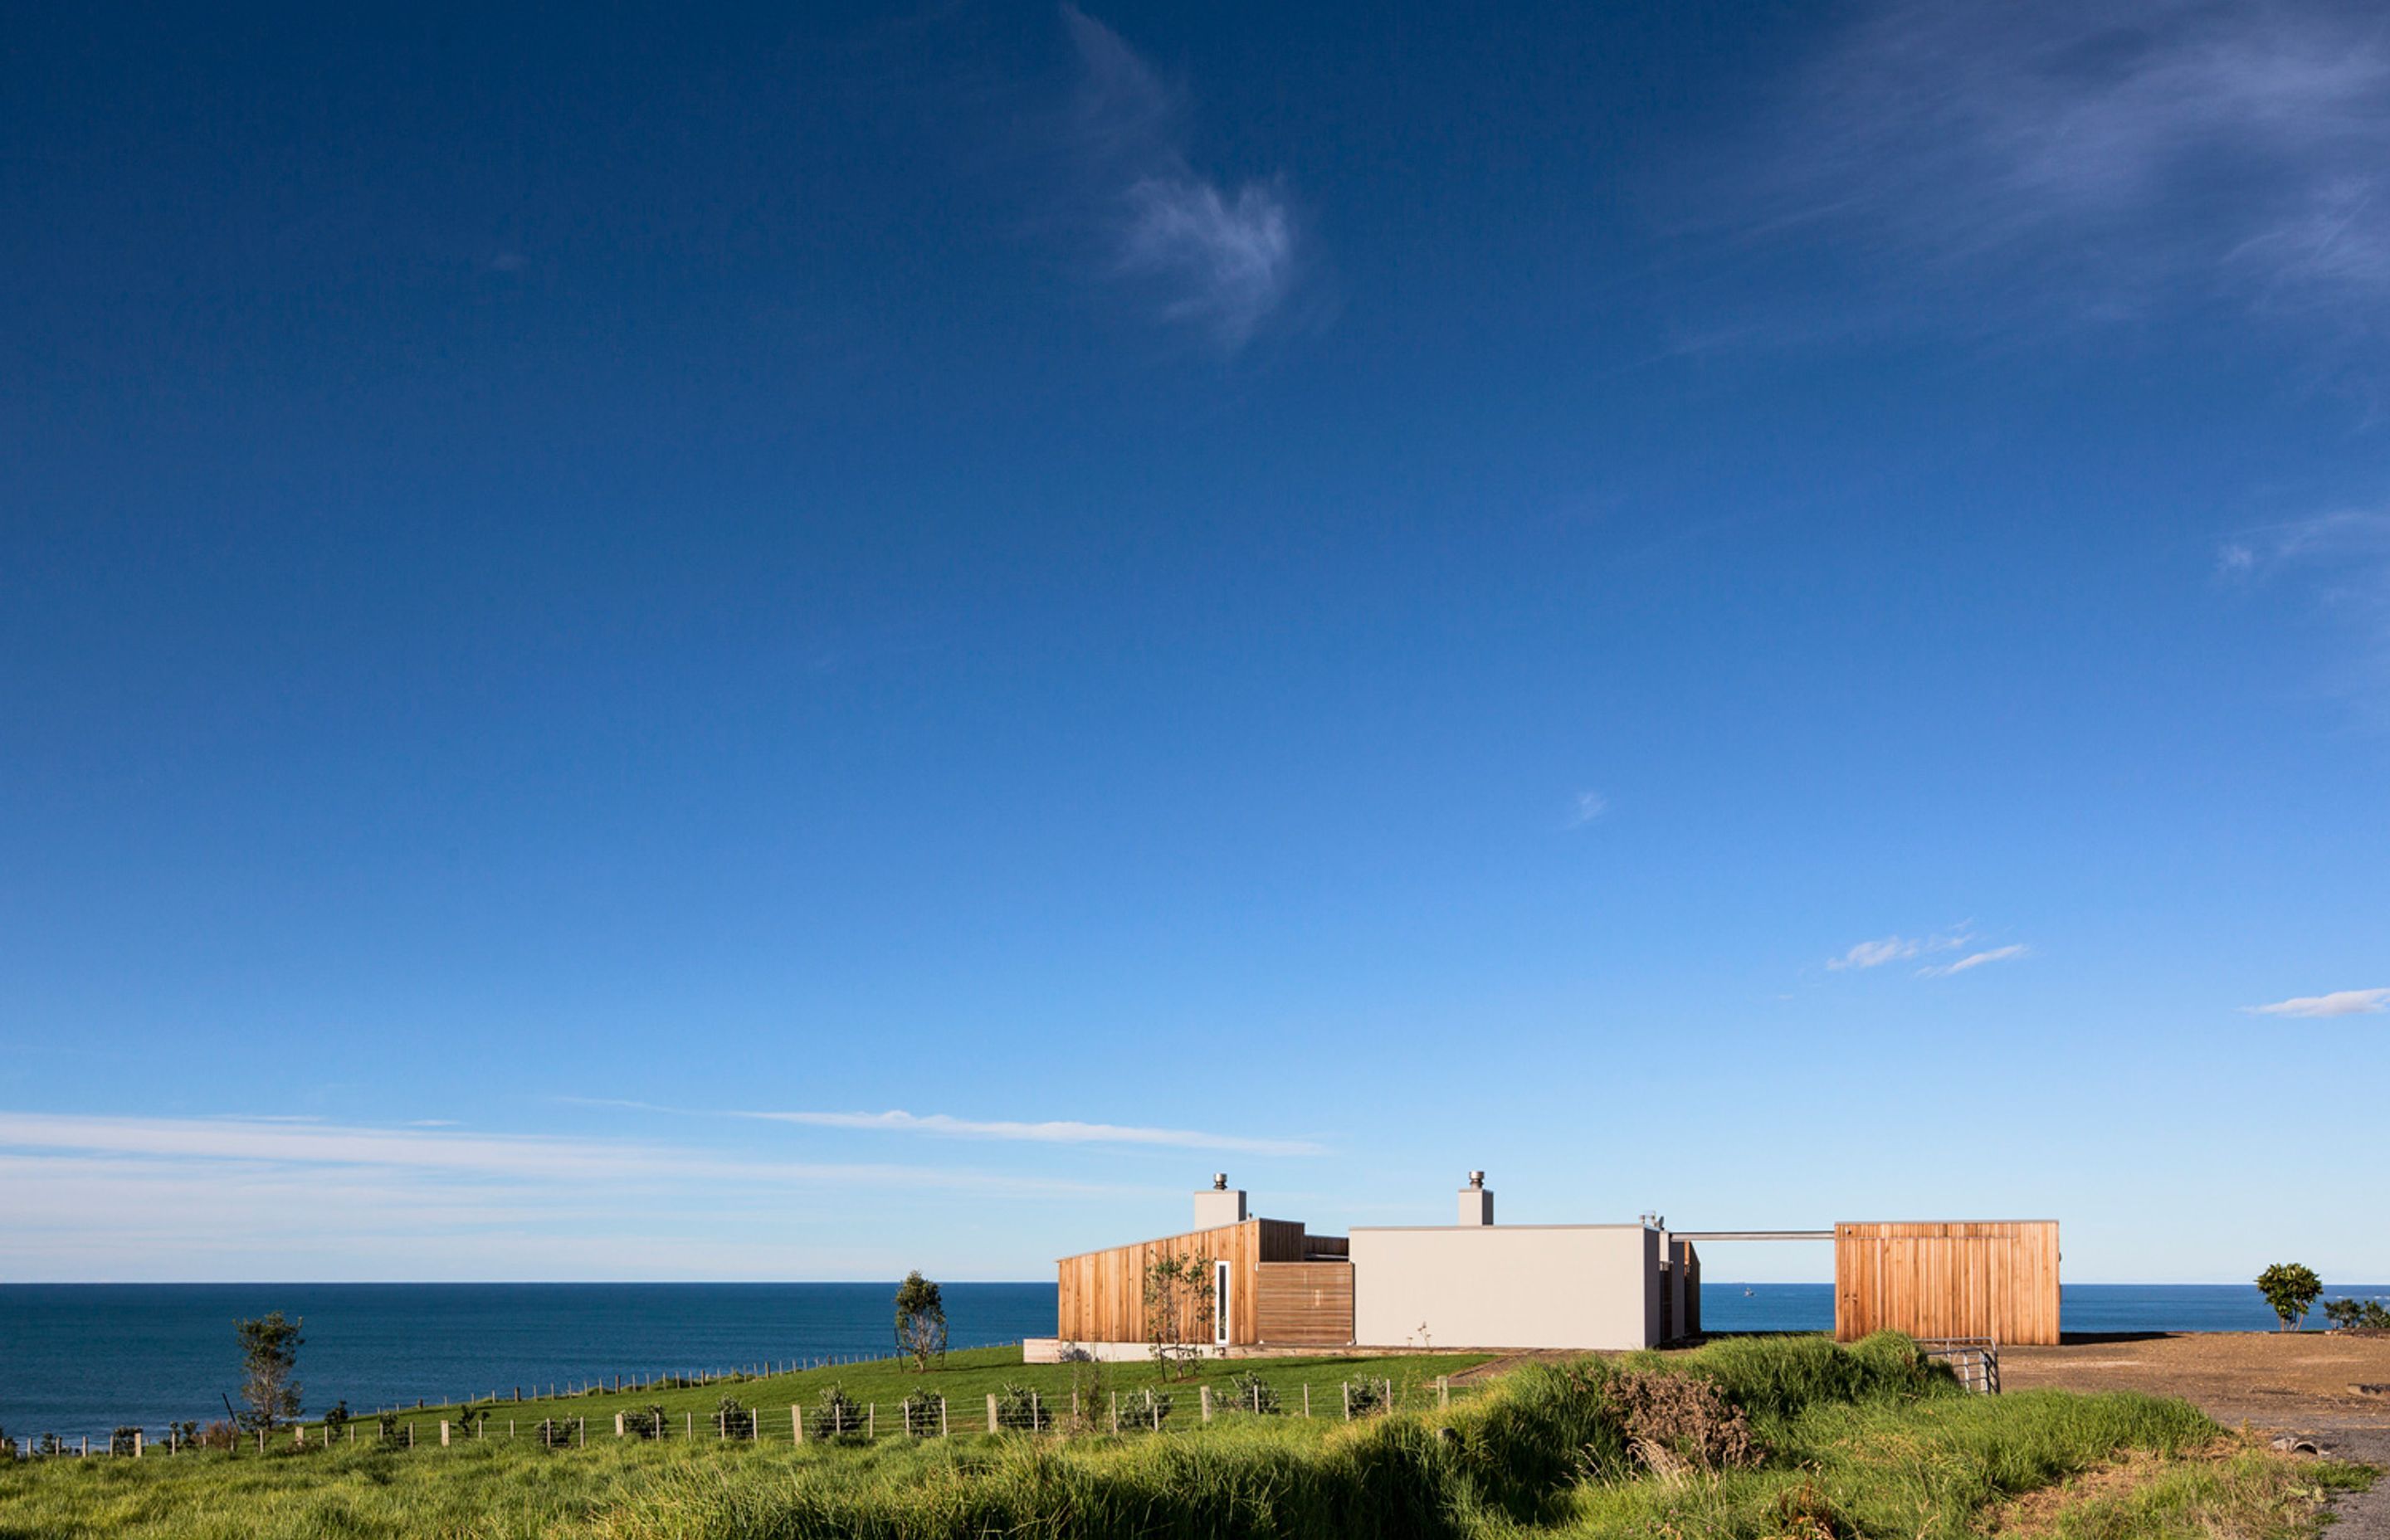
xmin=0 ymin=5 xmax=2390 ymax=1282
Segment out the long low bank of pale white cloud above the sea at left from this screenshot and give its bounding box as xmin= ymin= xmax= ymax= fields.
xmin=0 ymin=1112 xmax=1121 ymax=1282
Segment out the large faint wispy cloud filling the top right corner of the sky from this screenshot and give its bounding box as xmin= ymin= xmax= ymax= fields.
xmin=1735 ymin=0 xmax=2390 ymax=328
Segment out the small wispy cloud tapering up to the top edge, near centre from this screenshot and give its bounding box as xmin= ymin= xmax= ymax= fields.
xmin=1061 ymin=5 xmax=1307 ymax=354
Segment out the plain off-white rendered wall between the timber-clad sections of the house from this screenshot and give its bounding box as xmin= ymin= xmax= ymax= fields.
xmin=1353 ymin=1225 xmax=1659 ymax=1348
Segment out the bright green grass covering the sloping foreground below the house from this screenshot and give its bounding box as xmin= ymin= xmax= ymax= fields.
xmin=0 ymin=1337 xmax=2363 ymax=1540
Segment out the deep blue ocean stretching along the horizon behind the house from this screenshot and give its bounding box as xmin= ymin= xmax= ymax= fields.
xmin=0 ymin=1279 xmax=2390 ymax=1440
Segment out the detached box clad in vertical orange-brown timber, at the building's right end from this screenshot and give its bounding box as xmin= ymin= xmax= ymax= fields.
xmin=1833 ymin=1220 xmax=2058 ymax=1344
